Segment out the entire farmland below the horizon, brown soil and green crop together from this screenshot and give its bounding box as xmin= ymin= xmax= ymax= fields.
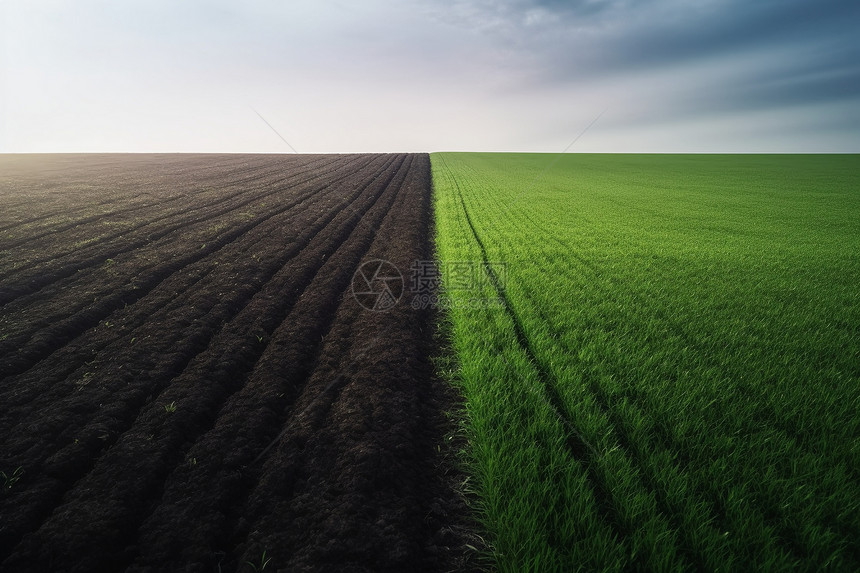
xmin=0 ymin=153 xmax=860 ymax=572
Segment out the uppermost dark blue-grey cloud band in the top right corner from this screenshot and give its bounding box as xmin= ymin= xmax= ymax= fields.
xmin=490 ymin=0 xmax=860 ymax=72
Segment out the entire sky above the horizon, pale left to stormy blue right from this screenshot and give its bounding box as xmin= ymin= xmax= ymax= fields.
xmin=0 ymin=0 xmax=860 ymax=153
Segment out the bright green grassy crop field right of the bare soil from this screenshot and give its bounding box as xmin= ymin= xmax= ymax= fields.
xmin=431 ymin=153 xmax=860 ymax=571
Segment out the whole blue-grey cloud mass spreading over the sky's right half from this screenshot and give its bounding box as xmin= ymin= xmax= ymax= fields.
xmin=414 ymin=0 xmax=860 ymax=150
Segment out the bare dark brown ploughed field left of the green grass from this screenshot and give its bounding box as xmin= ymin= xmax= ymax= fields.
xmin=0 ymin=154 xmax=470 ymax=571
